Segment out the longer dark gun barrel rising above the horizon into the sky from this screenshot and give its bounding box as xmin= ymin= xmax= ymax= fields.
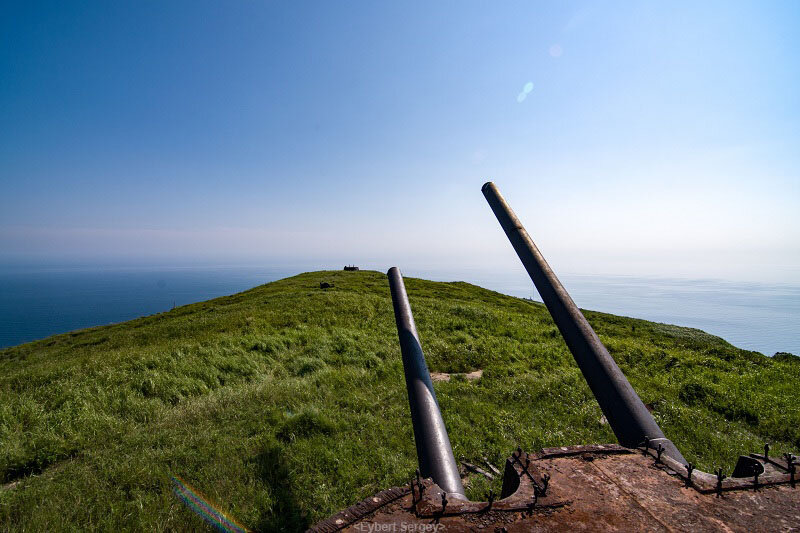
xmin=481 ymin=182 xmax=686 ymax=464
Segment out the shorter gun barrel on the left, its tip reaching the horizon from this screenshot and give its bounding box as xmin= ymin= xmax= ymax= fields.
xmin=387 ymin=267 xmax=466 ymax=499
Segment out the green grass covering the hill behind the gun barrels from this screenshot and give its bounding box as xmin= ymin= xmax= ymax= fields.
xmin=0 ymin=271 xmax=800 ymax=531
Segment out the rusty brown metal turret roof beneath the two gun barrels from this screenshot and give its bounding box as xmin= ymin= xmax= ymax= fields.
xmin=309 ymin=444 xmax=800 ymax=533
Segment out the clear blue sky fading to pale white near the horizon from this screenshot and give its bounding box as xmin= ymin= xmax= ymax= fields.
xmin=0 ymin=1 xmax=800 ymax=283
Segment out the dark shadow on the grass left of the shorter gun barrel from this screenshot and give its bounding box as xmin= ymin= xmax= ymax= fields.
xmin=254 ymin=443 xmax=309 ymax=531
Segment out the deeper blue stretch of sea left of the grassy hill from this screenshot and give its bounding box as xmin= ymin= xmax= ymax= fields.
xmin=0 ymin=267 xmax=300 ymax=348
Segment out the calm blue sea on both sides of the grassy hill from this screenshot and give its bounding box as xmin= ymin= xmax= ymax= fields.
xmin=0 ymin=267 xmax=800 ymax=355
